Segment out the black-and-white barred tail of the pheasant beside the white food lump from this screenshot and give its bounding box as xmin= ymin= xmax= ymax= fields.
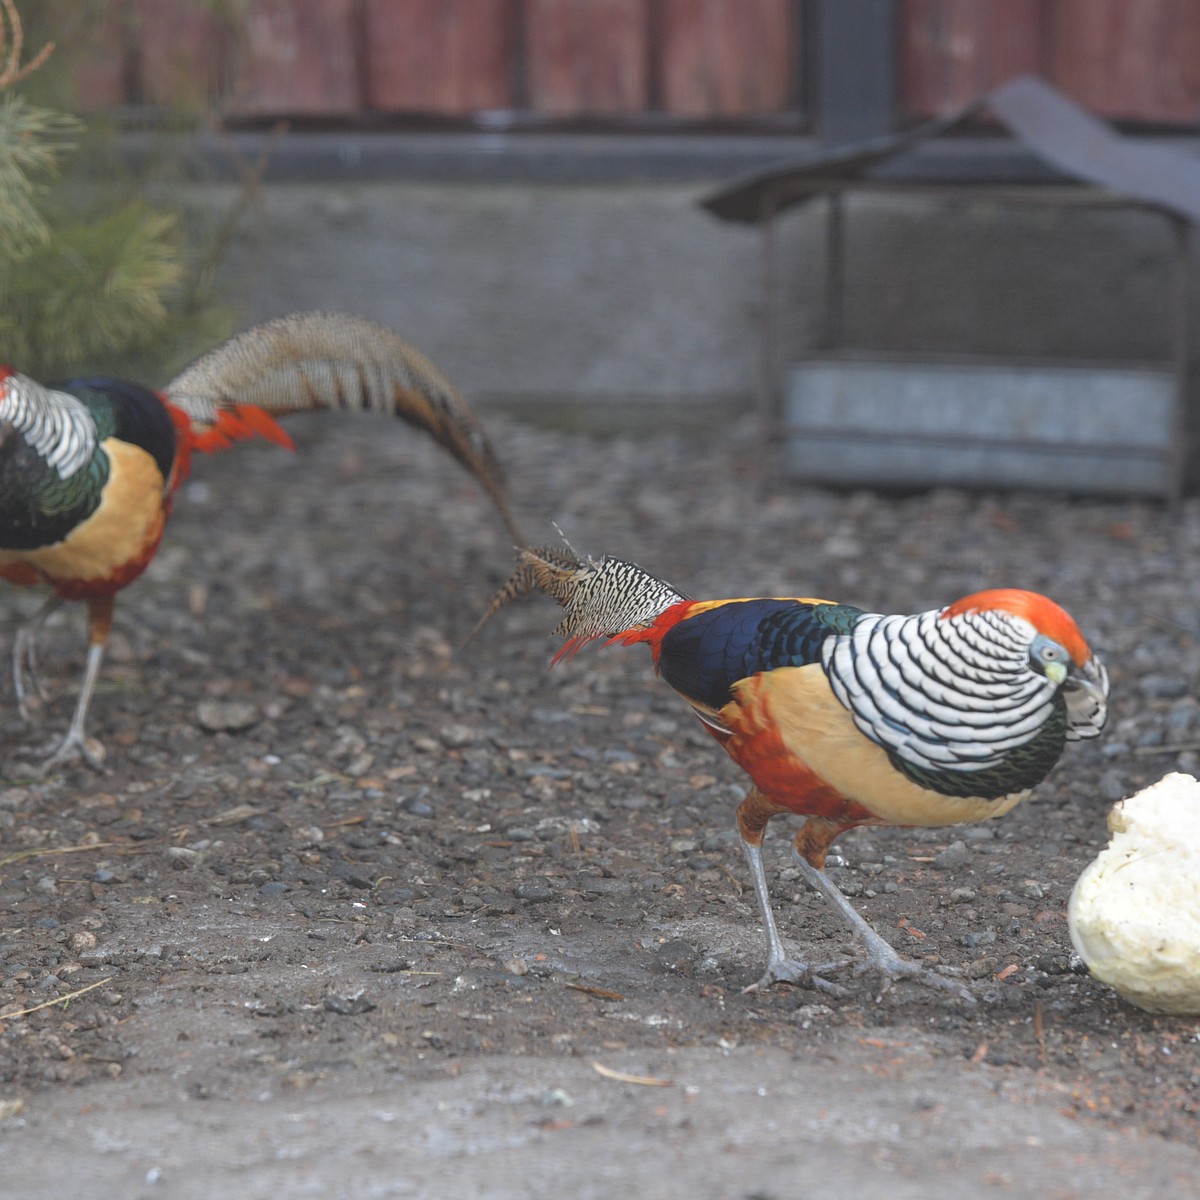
xmin=472 ymin=546 xmax=688 ymax=662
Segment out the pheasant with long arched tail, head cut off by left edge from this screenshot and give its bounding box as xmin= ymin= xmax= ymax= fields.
xmin=0 ymin=304 xmax=523 ymax=766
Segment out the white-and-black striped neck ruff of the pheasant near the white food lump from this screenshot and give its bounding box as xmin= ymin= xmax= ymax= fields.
xmin=822 ymin=610 xmax=1058 ymax=773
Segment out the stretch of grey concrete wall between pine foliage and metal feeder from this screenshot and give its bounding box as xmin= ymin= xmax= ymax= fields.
xmin=204 ymin=175 xmax=758 ymax=400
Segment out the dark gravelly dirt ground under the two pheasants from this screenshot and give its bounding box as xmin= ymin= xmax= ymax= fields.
xmin=0 ymin=414 xmax=1200 ymax=1200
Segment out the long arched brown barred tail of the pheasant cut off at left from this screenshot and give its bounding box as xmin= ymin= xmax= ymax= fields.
xmin=166 ymin=312 xmax=524 ymax=545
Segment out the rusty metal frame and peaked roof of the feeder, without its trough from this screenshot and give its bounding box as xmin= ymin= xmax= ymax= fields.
xmin=702 ymin=77 xmax=1200 ymax=509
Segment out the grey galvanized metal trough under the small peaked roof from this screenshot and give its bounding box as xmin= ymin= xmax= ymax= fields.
xmin=784 ymin=355 xmax=1176 ymax=497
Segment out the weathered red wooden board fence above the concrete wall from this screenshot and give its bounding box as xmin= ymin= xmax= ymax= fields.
xmin=83 ymin=0 xmax=1200 ymax=128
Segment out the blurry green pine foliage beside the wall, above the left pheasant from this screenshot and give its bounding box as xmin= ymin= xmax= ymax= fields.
xmin=0 ymin=0 xmax=229 ymax=382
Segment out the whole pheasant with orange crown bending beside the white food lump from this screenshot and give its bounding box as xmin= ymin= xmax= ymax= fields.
xmin=480 ymin=547 xmax=1109 ymax=1000
